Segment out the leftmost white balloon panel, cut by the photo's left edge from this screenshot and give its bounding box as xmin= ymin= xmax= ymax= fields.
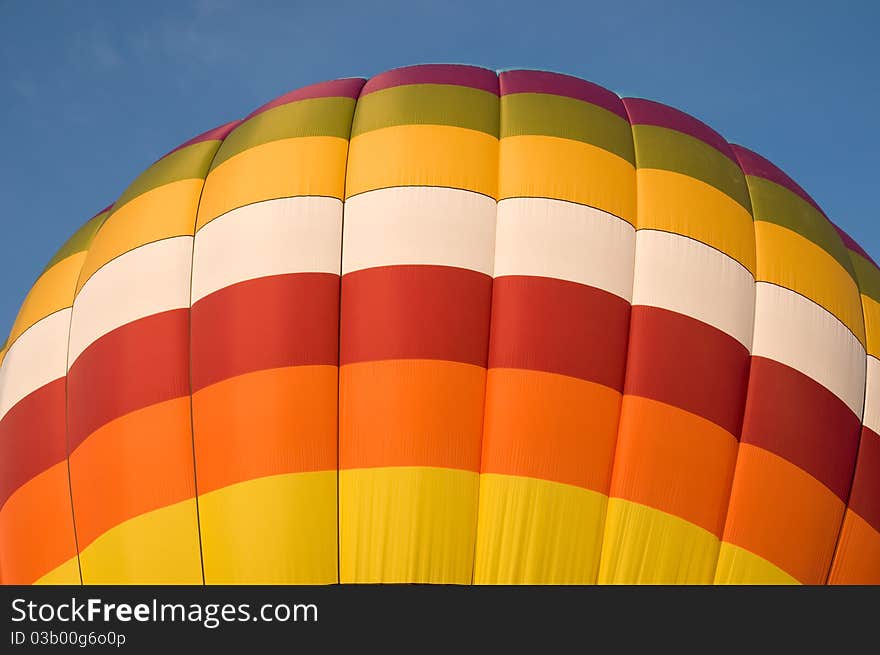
xmin=0 ymin=307 xmax=70 ymax=420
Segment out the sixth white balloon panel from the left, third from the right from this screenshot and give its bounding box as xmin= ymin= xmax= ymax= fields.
xmin=633 ymin=230 xmax=755 ymax=349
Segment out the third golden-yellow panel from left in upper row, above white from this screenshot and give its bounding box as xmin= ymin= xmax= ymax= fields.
xmin=196 ymin=136 xmax=348 ymax=229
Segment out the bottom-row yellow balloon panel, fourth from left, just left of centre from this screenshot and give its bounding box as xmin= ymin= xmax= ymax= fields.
xmin=339 ymin=467 xmax=479 ymax=584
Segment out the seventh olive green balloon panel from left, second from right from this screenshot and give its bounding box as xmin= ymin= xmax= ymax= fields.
xmin=747 ymin=175 xmax=856 ymax=279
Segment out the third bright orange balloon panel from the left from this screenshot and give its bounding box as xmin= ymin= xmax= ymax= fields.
xmin=193 ymin=366 xmax=337 ymax=494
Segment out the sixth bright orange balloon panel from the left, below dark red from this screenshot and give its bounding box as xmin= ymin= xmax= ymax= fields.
xmin=611 ymin=395 xmax=737 ymax=537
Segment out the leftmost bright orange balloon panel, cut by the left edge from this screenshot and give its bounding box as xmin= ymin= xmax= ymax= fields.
xmin=0 ymin=461 xmax=76 ymax=584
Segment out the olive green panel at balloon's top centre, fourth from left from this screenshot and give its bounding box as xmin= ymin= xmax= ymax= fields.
xmin=351 ymin=84 xmax=498 ymax=138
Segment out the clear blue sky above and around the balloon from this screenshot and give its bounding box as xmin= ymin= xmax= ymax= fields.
xmin=0 ymin=0 xmax=880 ymax=336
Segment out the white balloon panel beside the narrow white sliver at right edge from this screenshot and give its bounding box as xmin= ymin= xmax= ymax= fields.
xmin=753 ymin=282 xmax=865 ymax=416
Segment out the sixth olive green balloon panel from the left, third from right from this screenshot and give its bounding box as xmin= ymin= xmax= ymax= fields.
xmin=633 ymin=125 xmax=751 ymax=211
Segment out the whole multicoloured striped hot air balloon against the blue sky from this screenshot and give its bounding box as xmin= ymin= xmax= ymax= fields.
xmin=0 ymin=65 xmax=880 ymax=584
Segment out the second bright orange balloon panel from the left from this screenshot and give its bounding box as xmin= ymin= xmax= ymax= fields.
xmin=70 ymin=396 xmax=195 ymax=550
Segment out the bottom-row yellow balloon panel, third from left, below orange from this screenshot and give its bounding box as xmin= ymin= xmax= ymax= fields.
xmin=199 ymin=470 xmax=336 ymax=585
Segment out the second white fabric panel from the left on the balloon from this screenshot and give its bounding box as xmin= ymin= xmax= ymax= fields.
xmin=68 ymin=236 xmax=192 ymax=366
